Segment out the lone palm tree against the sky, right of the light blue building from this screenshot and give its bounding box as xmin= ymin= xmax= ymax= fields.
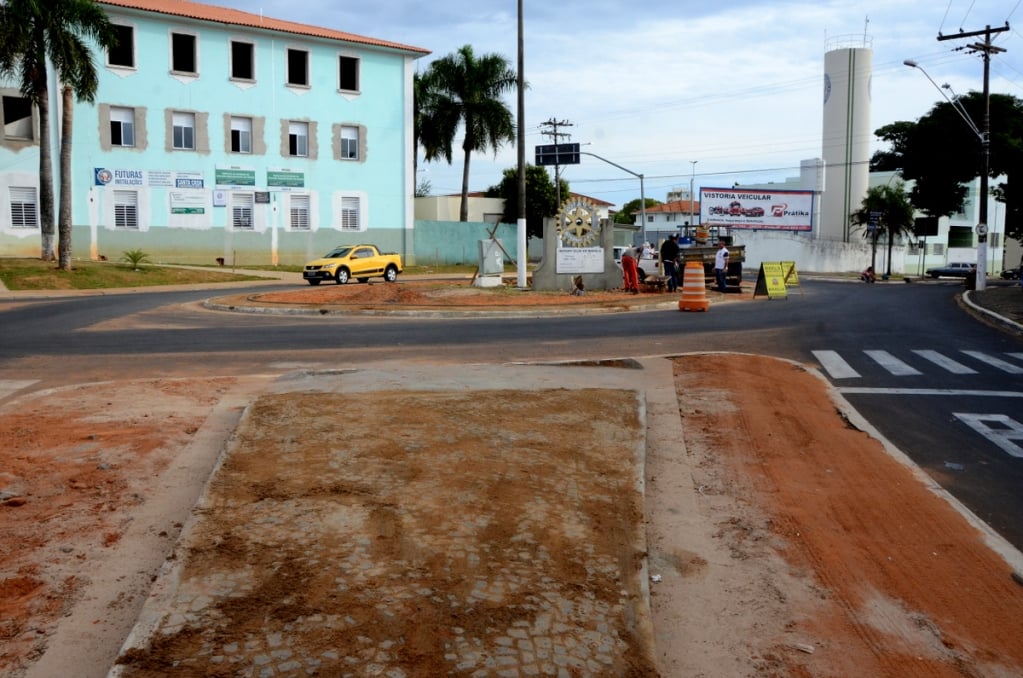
xmin=415 ymin=45 xmax=518 ymax=221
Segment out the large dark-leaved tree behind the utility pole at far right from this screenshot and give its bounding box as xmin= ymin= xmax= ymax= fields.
xmin=871 ymin=92 xmax=1023 ymax=246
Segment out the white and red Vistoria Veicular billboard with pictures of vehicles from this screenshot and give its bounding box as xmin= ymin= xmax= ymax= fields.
xmin=700 ymin=188 xmax=813 ymax=231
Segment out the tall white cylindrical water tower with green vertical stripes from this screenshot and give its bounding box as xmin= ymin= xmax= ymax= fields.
xmin=817 ymin=35 xmax=874 ymax=242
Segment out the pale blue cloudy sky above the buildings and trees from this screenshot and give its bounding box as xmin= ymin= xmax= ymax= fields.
xmin=211 ymin=0 xmax=1023 ymax=207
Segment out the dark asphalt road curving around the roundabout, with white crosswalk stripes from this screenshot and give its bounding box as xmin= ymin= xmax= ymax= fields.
xmin=0 ymin=279 xmax=1023 ymax=548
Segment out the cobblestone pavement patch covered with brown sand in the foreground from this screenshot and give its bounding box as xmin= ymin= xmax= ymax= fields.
xmin=105 ymin=366 xmax=657 ymax=678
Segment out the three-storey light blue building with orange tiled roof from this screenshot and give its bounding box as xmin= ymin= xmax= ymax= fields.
xmin=0 ymin=0 xmax=429 ymax=265
